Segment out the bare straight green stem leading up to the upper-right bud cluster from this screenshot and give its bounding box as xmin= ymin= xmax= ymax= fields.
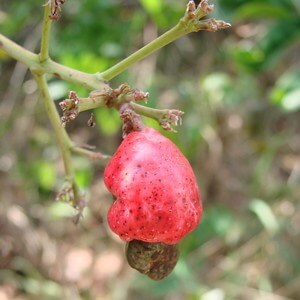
xmin=96 ymin=23 xmax=188 ymax=80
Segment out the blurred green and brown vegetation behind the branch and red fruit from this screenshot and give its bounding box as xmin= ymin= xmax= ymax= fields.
xmin=0 ymin=0 xmax=300 ymax=300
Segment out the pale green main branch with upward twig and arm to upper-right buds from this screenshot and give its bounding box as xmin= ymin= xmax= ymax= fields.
xmin=0 ymin=0 xmax=230 ymax=89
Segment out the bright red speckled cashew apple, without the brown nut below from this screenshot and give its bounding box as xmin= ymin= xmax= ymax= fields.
xmin=104 ymin=128 xmax=202 ymax=244
